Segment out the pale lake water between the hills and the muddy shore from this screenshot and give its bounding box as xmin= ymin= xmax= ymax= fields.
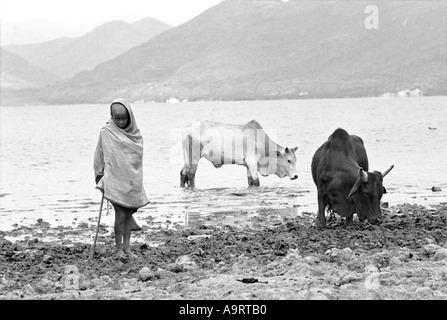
xmin=0 ymin=97 xmax=447 ymax=230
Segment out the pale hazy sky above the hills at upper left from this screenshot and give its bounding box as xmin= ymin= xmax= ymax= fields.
xmin=0 ymin=0 xmax=222 ymax=25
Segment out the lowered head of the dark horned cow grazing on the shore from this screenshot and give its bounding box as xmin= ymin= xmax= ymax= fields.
xmin=348 ymin=165 xmax=394 ymax=224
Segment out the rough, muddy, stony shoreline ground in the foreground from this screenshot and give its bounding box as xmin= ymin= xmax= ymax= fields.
xmin=0 ymin=203 xmax=447 ymax=300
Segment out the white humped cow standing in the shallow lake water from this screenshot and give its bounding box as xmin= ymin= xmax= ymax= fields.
xmin=180 ymin=120 xmax=298 ymax=188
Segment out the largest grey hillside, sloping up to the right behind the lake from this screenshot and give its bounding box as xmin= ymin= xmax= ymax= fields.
xmin=3 ymin=0 xmax=447 ymax=103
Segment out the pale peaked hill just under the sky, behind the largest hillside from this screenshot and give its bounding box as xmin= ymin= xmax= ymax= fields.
xmin=5 ymin=18 xmax=171 ymax=79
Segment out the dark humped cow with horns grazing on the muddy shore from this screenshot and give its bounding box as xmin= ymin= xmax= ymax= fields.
xmin=311 ymin=129 xmax=394 ymax=228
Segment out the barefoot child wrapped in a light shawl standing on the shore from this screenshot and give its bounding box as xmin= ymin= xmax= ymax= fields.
xmin=93 ymin=99 xmax=149 ymax=257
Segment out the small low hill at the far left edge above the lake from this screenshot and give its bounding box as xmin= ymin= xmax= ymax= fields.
xmin=0 ymin=49 xmax=59 ymax=90
